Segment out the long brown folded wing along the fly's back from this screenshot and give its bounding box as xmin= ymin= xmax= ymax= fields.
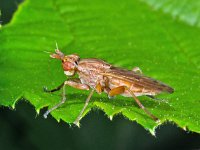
xmin=104 ymin=67 xmax=174 ymax=93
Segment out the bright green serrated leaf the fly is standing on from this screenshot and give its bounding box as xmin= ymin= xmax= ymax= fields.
xmin=0 ymin=0 xmax=200 ymax=134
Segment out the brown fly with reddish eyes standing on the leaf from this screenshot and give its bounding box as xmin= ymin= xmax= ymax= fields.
xmin=44 ymin=48 xmax=174 ymax=125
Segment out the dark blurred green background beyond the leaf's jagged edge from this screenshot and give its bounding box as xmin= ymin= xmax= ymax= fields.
xmin=0 ymin=0 xmax=200 ymax=150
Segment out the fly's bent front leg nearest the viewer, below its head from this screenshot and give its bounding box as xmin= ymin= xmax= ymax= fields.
xmin=43 ymin=80 xmax=89 ymax=118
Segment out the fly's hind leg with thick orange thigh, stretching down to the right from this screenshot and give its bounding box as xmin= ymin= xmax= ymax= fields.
xmin=109 ymin=86 xmax=160 ymax=122
